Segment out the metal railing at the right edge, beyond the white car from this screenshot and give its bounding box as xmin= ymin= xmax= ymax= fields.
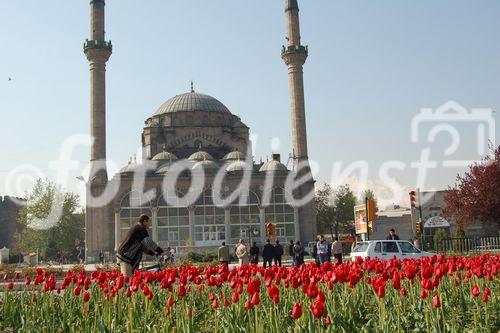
xmin=435 ymin=237 xmax=500 ymax=254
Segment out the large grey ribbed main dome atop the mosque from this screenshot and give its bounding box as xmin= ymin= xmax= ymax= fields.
xmin=155 ymin=91 xmax=231 ymax=115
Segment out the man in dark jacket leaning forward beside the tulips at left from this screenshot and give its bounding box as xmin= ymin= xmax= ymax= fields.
xmin=116 ymin=215 xmax=163 ymax=277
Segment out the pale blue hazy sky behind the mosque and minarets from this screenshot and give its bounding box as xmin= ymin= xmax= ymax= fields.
xmin=0 ymin=0 xmax=500 ymax=208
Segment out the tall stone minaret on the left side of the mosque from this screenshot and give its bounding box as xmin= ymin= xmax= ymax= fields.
xmin=83 ymin=0 xmax=112 ymax=184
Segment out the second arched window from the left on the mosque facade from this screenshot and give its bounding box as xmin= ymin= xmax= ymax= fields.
xmin=158 ymin=191 xmax=189 ymax=247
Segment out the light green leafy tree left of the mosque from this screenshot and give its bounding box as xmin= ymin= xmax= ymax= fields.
xmin=13 ymin=179 xmax=85 ymax=259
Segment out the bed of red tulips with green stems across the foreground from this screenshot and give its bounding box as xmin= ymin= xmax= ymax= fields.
xmin=0 ymin=255 xmax=500 ymax=332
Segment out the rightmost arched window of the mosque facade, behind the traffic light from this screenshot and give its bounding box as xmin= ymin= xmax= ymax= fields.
xmin=265 ymin=187 xmax=296 ymax=242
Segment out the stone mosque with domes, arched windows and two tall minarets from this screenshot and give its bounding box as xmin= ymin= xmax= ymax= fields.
xmin=84 ymin=0 xmax=316 ymax=258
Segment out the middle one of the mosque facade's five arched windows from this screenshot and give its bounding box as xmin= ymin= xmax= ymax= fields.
xmin=194 ymin=189 xmax=226 ymax=246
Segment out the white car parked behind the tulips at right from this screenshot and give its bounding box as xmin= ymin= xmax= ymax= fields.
xmin=351 ymin=240 xmax=434 ymax=260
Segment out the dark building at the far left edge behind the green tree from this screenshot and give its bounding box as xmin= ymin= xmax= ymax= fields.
xmin=0 ymin=195 xmax=23 ymax=249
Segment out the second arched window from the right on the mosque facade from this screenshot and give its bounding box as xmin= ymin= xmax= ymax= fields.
xmin=230 ymin=191 xmax=260 ymax=244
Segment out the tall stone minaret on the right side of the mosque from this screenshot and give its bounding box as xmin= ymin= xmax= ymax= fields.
xmin=281 ymin=0 xmax=308 ymax=168
